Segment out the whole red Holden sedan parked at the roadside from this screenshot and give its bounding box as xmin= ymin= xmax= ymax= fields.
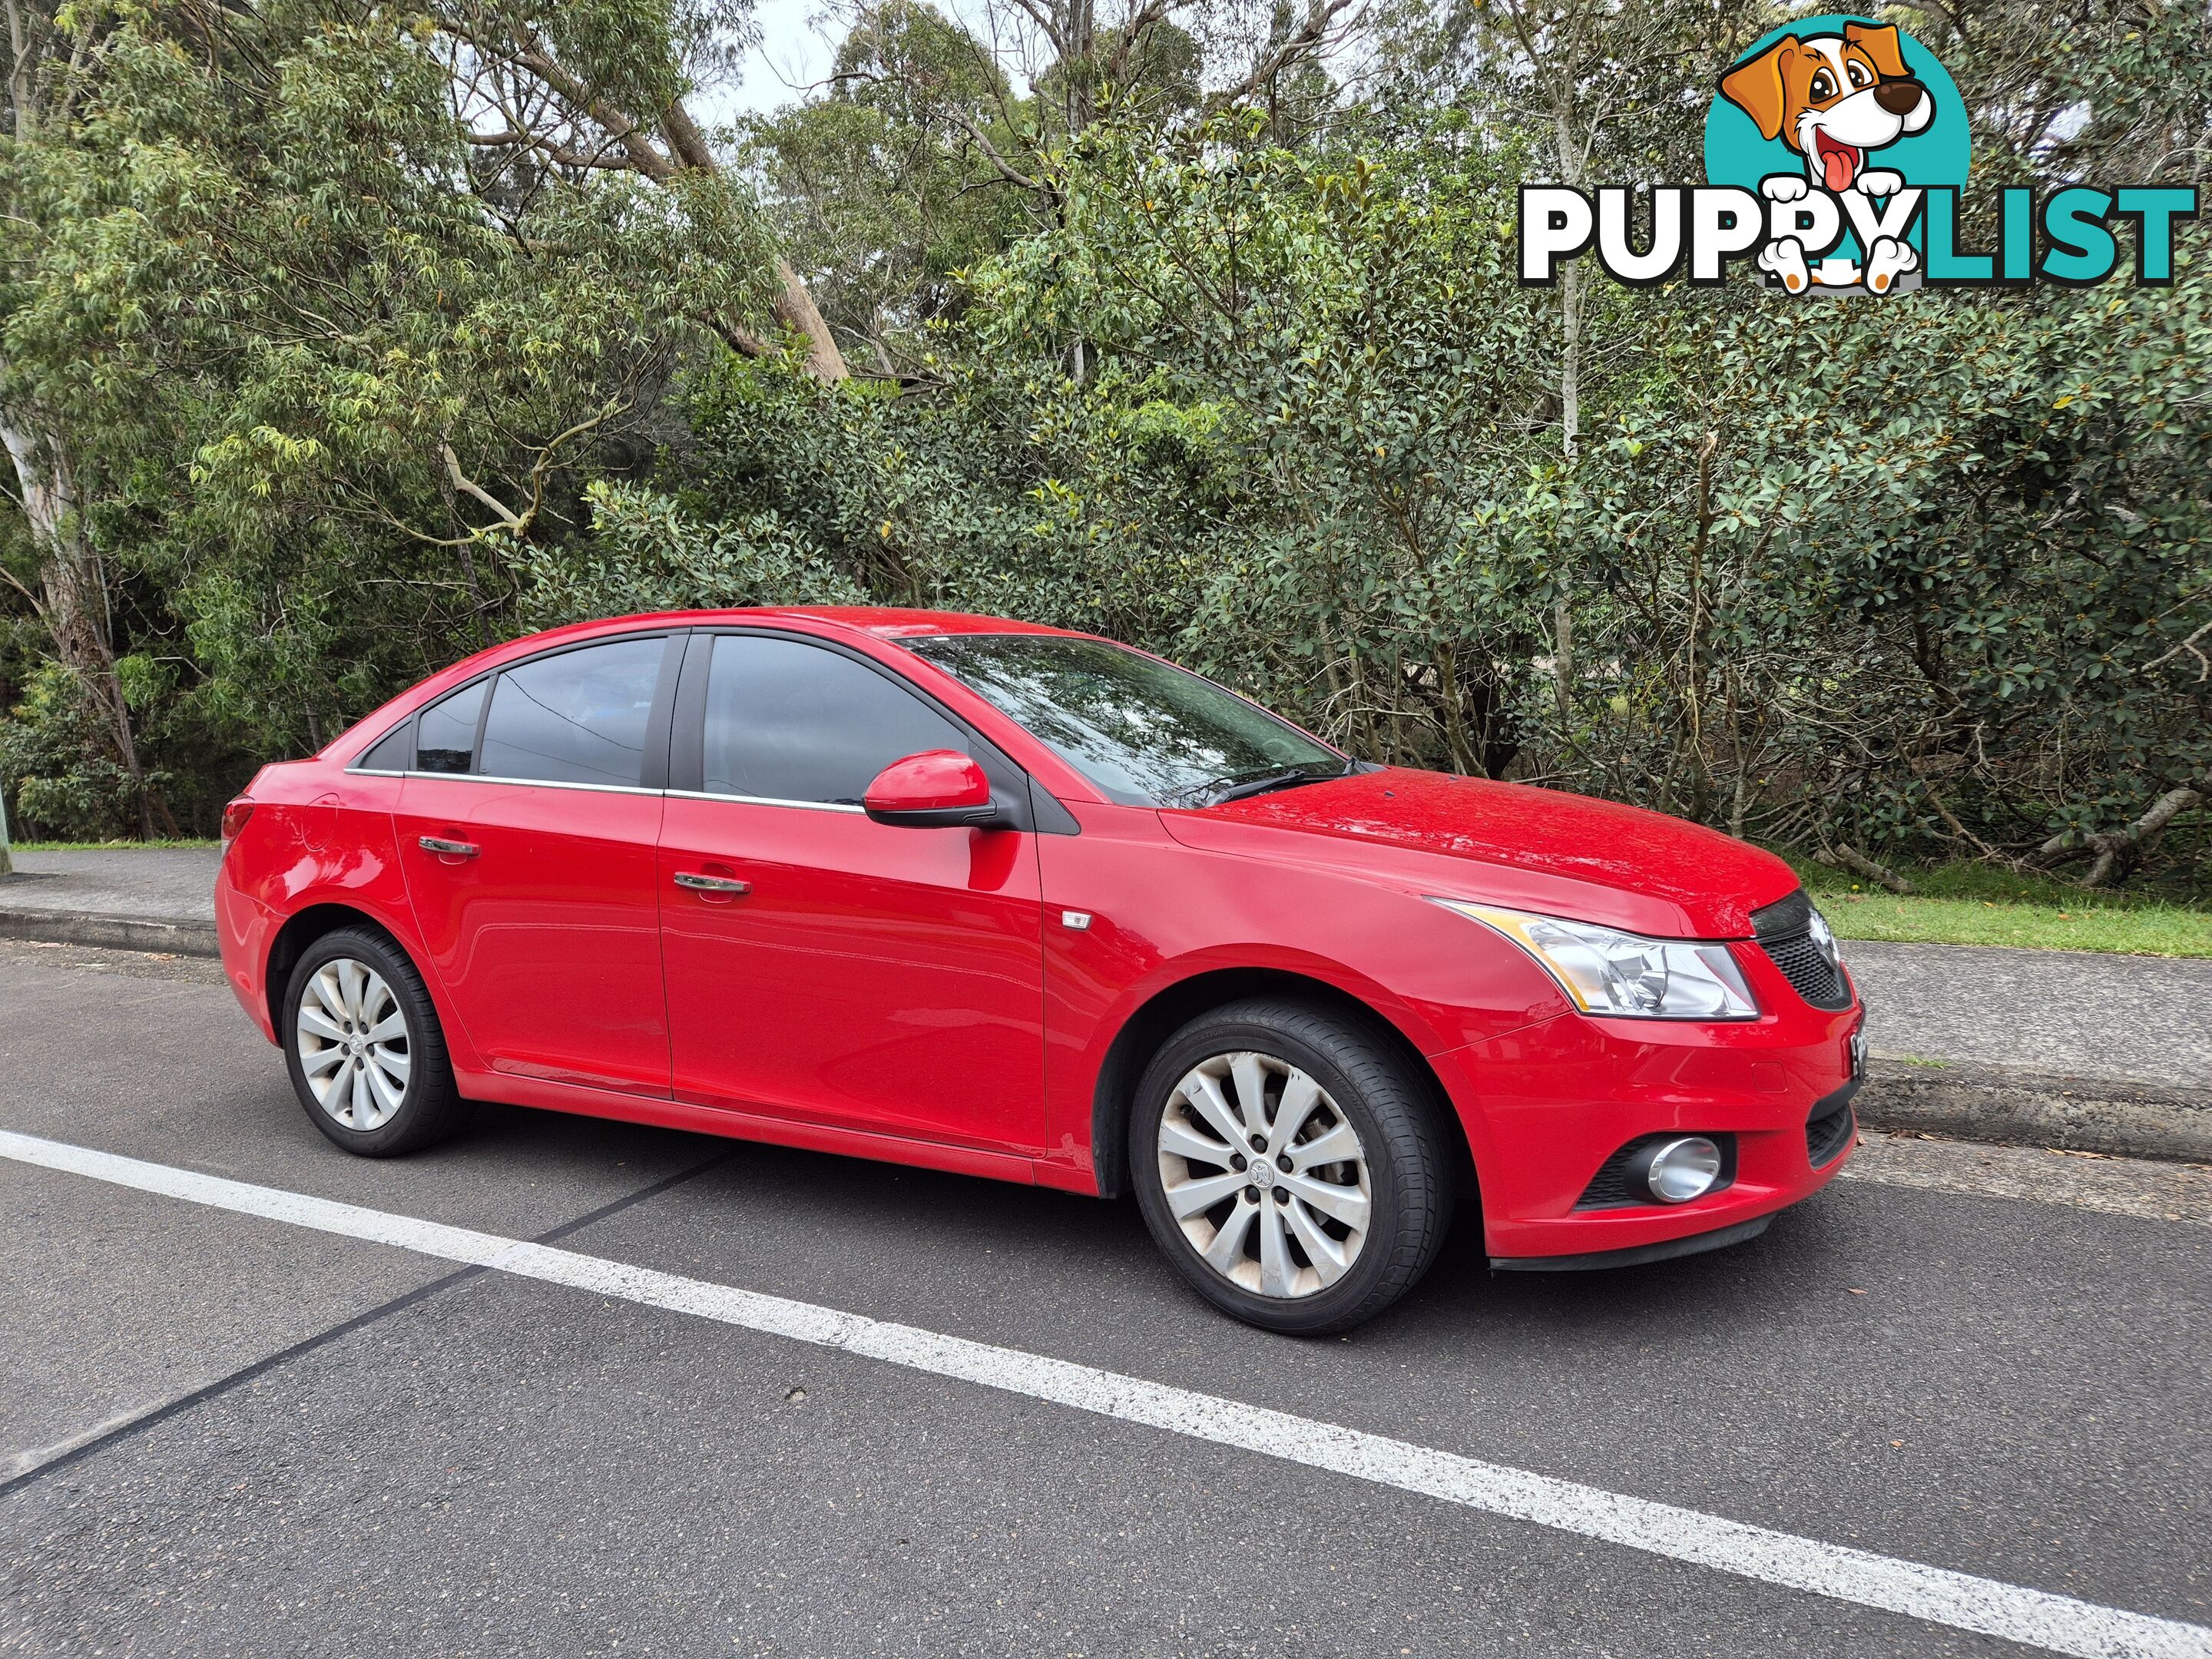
xmin=217 ymin=608 xmax=1860 ymax=1334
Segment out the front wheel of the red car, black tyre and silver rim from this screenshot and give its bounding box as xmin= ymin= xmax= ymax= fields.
xmin=1128 ymin=1000 xmax=1453 ymax=1336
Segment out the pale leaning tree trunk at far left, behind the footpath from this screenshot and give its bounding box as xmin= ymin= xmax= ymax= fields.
xmin=0 ymin=398 xmax=153 ymax=839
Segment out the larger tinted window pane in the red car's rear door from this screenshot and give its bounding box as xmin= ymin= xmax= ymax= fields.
xmin=478 ymin=639 xmax=666 ymax=785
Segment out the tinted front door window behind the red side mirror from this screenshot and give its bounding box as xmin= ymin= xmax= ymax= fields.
xmin=706 ymin=635 xmax=969 ymax=805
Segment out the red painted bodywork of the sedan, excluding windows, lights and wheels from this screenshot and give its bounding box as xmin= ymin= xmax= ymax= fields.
xmin=217 ymin=608 xmax=1860 ymax=1259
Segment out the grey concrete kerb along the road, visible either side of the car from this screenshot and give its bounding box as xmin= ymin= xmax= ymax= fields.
xmin=0 ymin=907 xmax=2212 ymax=1164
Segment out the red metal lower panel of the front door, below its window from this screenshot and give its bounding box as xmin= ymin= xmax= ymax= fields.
xmin=659 ymin=799 xmax=1044 ymax=1157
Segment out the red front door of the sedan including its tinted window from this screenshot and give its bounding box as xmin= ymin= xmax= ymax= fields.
xmin=659 ymin=633 xmax=1044 ymax=1152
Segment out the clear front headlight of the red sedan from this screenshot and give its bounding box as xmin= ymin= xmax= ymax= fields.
xmin=1435 ymin=898 xmax=1759 ymax=1020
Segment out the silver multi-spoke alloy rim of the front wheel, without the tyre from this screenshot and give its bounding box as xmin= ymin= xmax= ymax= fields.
xmin=1159 ymin=1051 xmax=1373 ymax=1300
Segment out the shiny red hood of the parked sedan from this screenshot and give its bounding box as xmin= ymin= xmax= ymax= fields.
xmin=1159 ymin=767 xmax=1798 ymax=938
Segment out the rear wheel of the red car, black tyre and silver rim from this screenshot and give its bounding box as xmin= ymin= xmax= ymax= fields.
xmin=279 ymin=927 xmax=460 ymax=1157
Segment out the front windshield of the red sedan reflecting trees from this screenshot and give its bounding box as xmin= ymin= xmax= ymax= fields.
xmin=900 ymin=633 xmax=1352 ymax=807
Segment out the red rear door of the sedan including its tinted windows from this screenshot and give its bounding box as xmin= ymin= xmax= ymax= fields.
xmin=396 ymin=633 xmax=681 ymax=1095
